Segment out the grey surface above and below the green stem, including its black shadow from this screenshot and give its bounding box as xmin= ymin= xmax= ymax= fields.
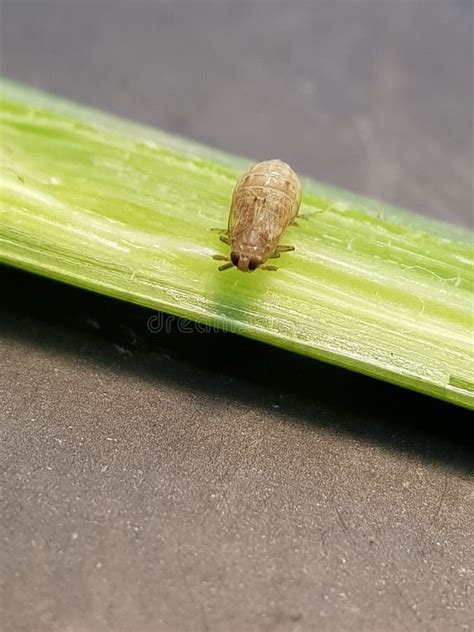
xmin=0 ymin=0 xmax=474 ymax=632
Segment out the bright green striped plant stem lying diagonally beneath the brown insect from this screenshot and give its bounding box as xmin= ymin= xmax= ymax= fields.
xmin=0 ymin=80 xmax=474 ymax=407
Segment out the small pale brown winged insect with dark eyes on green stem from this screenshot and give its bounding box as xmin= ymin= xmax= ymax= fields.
xmin=213 ymin=160 xmax=301 ymax=272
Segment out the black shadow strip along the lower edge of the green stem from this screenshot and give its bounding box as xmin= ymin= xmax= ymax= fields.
xmin=0 ymin=267 xmax=474 ymax=473
